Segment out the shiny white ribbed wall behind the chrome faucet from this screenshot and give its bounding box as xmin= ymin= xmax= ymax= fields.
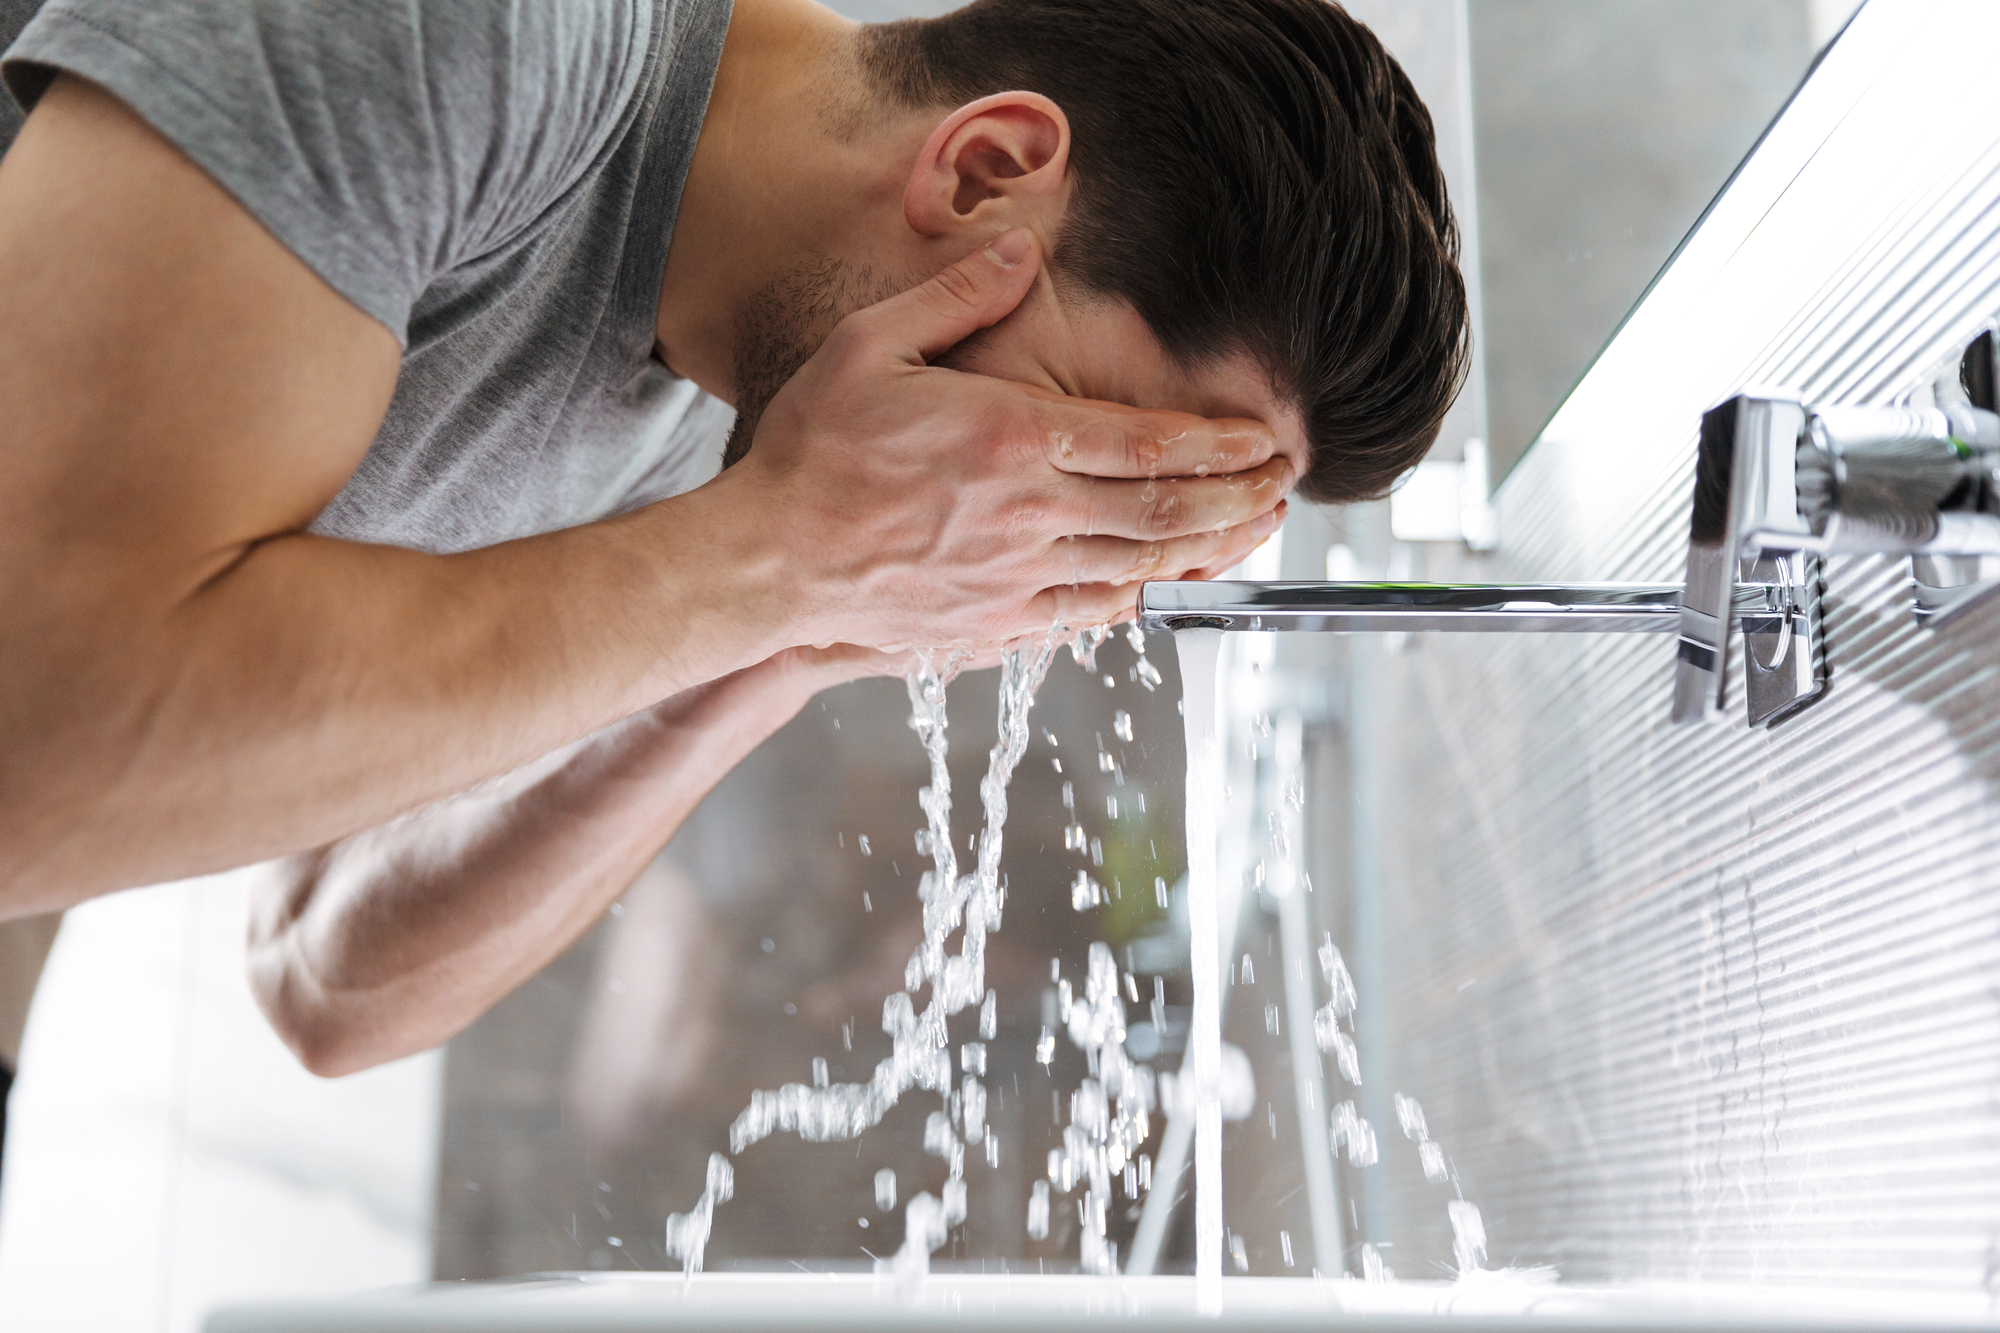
xmin=1328 ymin=2 xmax=2000 ymax=1293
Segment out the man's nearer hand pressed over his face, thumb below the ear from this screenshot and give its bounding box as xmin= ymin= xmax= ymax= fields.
xmin=714 ymin=230 xmax=1294 ymax=644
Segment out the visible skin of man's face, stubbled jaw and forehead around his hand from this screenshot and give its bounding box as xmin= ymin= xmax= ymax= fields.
xmin=722 ymin=256 xmax=1306 ymax=474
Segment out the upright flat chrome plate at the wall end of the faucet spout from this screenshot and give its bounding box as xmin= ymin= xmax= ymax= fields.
xmin=1672 ymin=394 xmax=1818 ymax=725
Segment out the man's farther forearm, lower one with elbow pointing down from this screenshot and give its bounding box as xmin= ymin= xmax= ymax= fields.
xmin=250 ymin=648 xmax=818 ymax=1075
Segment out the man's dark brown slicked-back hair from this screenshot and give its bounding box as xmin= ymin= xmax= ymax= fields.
xmin=862 ymin=0 xmax=1468 ymax=502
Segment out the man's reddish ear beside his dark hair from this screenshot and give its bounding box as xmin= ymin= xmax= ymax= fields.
xmin=902 ymin=92 xmax=1070 ymax=236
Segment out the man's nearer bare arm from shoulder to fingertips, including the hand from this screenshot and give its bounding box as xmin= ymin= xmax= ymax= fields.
xmin=0 ymin=78 xmax=1292 ymax=915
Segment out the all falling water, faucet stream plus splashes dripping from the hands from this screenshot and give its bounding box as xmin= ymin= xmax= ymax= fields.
xmin=666 ymin=626 xmax=1486 ymax=1288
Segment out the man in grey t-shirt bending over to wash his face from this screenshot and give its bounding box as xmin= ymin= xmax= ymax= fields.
xmin=0 ymin=0 xmax=1464 ymax=1073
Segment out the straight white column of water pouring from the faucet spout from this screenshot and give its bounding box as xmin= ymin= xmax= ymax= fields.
xmin=1174 ymin=628 xmax=1222 ymax=1315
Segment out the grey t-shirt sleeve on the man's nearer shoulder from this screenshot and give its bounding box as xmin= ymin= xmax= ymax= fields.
xmin=0 ymin=0 xmax=650 ymax=342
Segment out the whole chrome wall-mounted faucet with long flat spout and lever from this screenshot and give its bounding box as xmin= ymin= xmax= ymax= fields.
xmin=1138 ymin=334 xmax=2000 ymax=727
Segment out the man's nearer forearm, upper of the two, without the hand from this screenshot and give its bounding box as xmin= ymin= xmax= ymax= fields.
xmin=0 ymin=478 xmax=788 ymax=915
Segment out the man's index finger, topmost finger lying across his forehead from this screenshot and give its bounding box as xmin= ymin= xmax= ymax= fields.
xmin=1024 ymin=388 xmax=1276 ymax=478
